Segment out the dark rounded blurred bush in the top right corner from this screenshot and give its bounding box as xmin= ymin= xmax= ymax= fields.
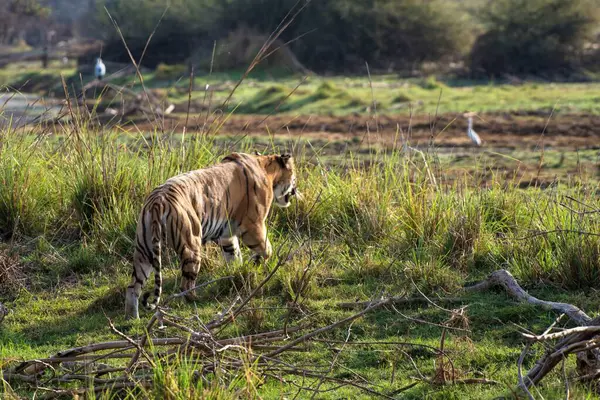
xmin=471 ymin=0 xmax=598 ymax=75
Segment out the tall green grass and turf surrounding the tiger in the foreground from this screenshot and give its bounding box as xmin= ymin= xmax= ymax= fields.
xmin=0 ymin=115 xmax=600 ymax=399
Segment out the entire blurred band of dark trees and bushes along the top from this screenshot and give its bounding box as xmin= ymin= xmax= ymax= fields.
xmin=0 ymin=0 xmax=600 ymax=80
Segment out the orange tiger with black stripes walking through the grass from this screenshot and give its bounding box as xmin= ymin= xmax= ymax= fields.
xmin=125 ymin=153 xmax=297 ymax=319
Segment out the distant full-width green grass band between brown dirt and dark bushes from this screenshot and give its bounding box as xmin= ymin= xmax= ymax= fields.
xmin=5 ymin=64 xmax=600 ymax=115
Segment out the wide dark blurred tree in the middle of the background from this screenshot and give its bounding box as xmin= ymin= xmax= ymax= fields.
xmin=213 ymin=0 xmax=472 ymax=72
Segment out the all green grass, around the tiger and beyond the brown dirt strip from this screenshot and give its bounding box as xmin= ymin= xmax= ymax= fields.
xmin=0 ymin=63 xmax=600 ymax=399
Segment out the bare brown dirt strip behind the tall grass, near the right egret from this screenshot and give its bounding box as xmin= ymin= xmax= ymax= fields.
xmin=136 ymin=113 xmax=600 ymax=150
